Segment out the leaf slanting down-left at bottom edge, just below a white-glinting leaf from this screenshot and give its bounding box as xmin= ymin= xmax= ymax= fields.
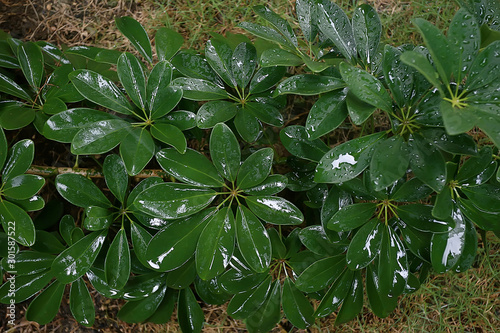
xmin=117 ymin=285 xmax=167 ymax=323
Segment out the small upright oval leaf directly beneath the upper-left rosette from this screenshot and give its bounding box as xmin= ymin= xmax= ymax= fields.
xmin=102 ymin=154 xmax=128 ymax=204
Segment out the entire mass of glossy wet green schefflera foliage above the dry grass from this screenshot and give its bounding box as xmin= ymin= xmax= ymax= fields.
xmin=0 ymin=0 xmax=500 ymax=332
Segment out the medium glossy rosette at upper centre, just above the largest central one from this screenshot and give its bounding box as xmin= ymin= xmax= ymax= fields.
xmin=172 ymin=38 xmax=286 ymax=142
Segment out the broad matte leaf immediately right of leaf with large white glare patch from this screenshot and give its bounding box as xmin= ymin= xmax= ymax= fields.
xmin=370 ymin=135 xmax=410 ymax=191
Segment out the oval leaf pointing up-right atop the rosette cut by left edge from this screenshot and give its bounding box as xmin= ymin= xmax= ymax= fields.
xmin=2 ymin=139 xmax=35 ymax=183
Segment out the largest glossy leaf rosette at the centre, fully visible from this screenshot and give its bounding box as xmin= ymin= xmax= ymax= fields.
xmin=134 ymin=124 xmax=303 ymax=280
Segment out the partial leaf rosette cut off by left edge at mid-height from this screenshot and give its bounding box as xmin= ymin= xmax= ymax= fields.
xmin=0 ymin=128 xmax=45 ymax=248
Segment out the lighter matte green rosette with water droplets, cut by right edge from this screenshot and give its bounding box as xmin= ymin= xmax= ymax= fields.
xmin=401 ymin=8 xmax=500 ymax=147
